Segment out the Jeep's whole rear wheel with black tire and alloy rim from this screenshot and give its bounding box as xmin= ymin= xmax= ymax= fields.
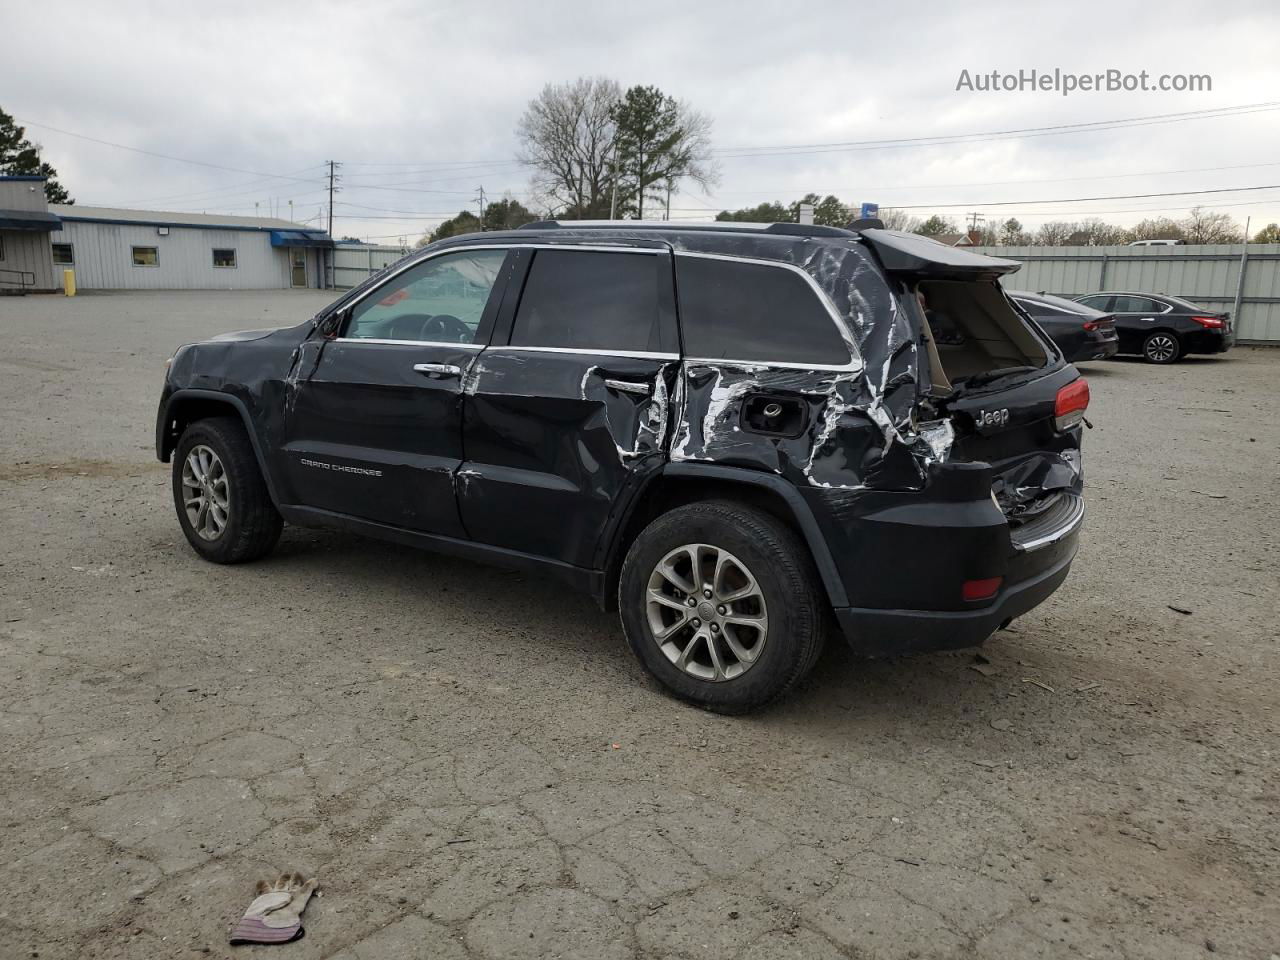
xmin=618 ymin=500 xmax=827 ymax=713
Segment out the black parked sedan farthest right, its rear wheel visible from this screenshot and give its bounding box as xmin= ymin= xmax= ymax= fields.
xmin=1076 ymin=293 xmax=1235 ymax=364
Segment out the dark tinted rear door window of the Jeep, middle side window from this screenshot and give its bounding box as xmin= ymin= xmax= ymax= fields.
xmin=511 ymin=250 xmax=662 ymax=353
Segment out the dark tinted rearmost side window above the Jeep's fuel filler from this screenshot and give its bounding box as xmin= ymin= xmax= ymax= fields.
xmin=676 ymin=256 xmax=849 ymax=365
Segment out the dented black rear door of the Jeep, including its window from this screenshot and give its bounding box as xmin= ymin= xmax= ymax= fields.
xmin=458 ymin=243 xmax=678 ymax=568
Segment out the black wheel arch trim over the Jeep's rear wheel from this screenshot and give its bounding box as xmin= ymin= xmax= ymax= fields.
xmin=598 ymin=463 xmax=849 ymax=609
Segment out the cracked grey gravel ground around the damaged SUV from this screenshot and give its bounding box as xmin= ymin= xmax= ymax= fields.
xmin=0 ymin=292 xmax=1280 ymax=960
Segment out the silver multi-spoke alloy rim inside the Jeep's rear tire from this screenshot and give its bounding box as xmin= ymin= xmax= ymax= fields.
xmin=645 ymin=543 xmax=769 ymax=682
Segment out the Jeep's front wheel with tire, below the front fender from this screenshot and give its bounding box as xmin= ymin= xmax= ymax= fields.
xmin=173 ymin=417 xmax=284 ymax=563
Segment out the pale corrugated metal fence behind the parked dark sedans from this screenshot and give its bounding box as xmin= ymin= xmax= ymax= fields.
xmin=977 ymin=243 xmax=1280 ymax=343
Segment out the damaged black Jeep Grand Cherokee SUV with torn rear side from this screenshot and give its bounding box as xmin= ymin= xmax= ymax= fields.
xmin=156 ymin=221 xmax=1088 ymax=713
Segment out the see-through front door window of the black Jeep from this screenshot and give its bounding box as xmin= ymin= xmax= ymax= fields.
xmin=342 ymin=250 xmax=507 ymax=343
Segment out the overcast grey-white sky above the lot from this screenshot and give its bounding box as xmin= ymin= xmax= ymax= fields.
xmin=0 ymin=0 xmax=1280 ymax=244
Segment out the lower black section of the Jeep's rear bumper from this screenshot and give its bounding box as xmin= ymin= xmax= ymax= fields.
xmin=836 ymin=532 xmax=1079 ymax=657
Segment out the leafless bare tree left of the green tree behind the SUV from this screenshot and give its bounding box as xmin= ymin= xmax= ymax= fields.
xmin=516 ymin=77 xmax=622 ymax=219
